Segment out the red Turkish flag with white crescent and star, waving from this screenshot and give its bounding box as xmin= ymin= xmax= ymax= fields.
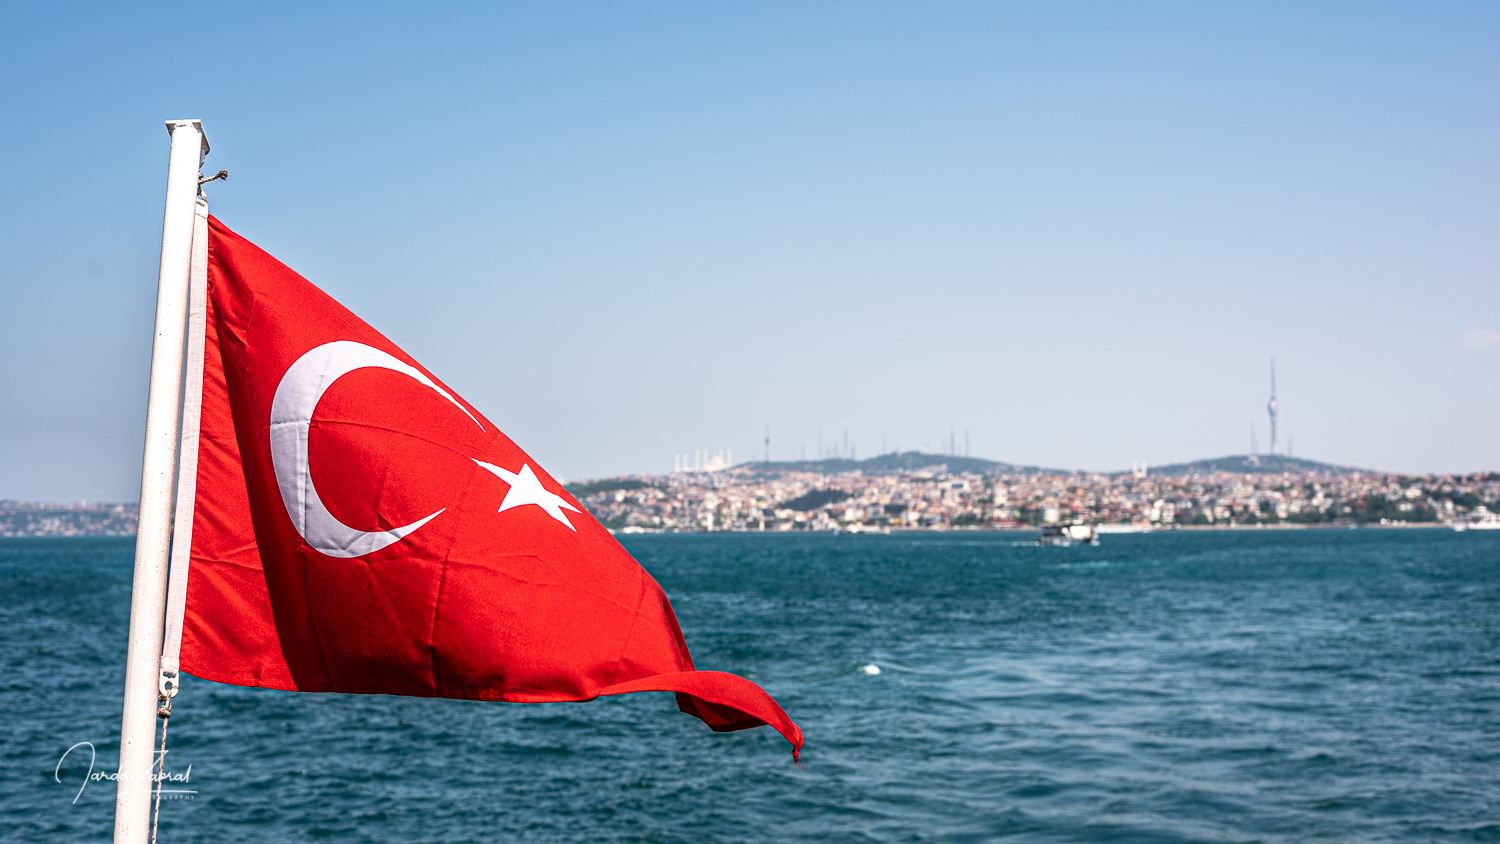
xmin=182 ymin=217 xmax=803 ymax=757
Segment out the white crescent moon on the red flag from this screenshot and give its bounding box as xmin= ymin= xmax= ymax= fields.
xmin=272 ymin=340 xmax=485 ymax=558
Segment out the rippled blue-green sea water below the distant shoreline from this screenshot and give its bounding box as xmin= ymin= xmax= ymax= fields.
xmin=0 ymin=529 xmax=1500 ymax=844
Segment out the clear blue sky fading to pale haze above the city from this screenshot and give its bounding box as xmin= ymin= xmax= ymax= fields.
xmin=0 ymin=1 xmax=1500 ymax=501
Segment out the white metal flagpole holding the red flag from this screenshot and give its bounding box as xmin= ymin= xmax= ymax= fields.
xmin=114 ymin=120 xmax=209 ymax=844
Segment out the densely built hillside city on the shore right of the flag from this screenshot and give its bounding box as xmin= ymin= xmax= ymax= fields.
xmin=570 ymin=453 xmax=1500 ymax=532
